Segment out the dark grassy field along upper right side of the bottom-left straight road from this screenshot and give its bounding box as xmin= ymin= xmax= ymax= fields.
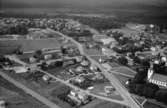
xmin=2 ymin=72 xmax=71 ymax=108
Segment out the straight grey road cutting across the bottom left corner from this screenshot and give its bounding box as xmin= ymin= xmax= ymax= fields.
xmin=0 ymin=71 xmax=60 ymax=108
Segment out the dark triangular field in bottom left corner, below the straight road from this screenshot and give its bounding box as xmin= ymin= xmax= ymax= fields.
xmin=0 ymin=74 xmax=48 ymax=108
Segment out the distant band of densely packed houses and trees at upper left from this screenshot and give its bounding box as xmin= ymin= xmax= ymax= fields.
xmin=0 ymin=17 xmax=81 ymax=34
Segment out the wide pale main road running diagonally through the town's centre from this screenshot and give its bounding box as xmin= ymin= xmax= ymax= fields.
xmin=53 ymin=30 xmax=141 ymax=108
